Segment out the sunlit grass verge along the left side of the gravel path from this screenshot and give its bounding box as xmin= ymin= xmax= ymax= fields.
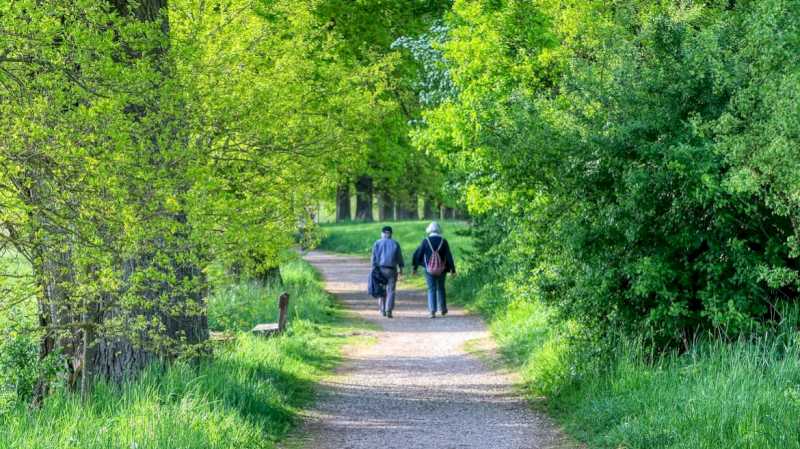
xmin=0 ymin=261 xmax=350 ymax=449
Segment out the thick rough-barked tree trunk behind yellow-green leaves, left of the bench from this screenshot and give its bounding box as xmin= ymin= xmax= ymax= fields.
xmin=84 ymin=0 xmax=208 ymax=383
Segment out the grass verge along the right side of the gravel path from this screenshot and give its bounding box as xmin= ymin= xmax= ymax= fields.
xmin=446 ymin=264 xmax=800 ymax=449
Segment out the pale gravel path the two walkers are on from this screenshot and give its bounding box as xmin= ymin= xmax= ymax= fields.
xmin=299 ymin=252 xmax=566 ymax=449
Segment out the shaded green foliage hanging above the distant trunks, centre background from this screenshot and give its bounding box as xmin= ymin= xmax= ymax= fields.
xmin=316 ymin=0 xmax=451 ymax=202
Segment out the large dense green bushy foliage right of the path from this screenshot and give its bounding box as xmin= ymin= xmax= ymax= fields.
xmin=414 ymin=0 xmax=800 ymax=347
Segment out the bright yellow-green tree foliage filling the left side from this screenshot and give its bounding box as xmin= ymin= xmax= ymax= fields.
xmin=0 ymin=0 xmax=400 ymax=388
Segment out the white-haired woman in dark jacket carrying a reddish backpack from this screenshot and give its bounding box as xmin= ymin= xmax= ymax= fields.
xmin=413 ymin=221 xmax=456 ymax=318
